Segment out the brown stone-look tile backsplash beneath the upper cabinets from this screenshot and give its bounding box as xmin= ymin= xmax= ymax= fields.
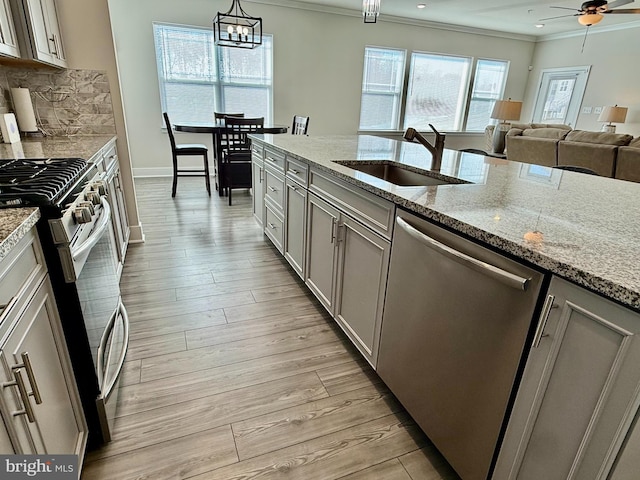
xmin=0 ymin=65 xmax=116 ymax=136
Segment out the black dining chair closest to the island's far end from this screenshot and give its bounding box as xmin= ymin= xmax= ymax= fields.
xmin=220 ymin=117 xmax=264 ymax=205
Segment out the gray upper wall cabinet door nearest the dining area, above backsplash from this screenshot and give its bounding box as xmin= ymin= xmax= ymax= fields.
xmin=11 ymin=0 xmax=67 ymax=68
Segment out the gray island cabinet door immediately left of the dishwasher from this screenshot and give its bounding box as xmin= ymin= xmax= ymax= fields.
xmin=335 ymin=216 xmax=391 ymax=367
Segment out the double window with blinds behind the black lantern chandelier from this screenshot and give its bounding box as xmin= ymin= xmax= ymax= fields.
xmin=153 ymin=23 xmax=273 ymax=123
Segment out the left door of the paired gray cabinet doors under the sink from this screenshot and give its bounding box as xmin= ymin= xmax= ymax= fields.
xmin=305 ymin=194 xmax=340 ymax=314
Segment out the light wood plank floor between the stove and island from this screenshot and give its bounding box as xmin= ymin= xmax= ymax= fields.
xmin=82 ymin=178 xmax=458 ymax=480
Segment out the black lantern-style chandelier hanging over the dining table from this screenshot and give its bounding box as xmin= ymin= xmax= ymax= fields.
xmin=213 ymin=0 xmax=262 ymax=48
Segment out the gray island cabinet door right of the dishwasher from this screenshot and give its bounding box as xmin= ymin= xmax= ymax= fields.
xmin=493 ymin=278 xmax=640 ymax=480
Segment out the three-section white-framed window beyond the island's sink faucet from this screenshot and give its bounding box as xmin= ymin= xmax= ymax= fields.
xmin=360 ymin=47 xmax=509 ymax=131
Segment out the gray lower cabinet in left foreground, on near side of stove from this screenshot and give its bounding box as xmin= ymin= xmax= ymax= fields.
xmin=0 ymin=227 xmax=87 ymax=456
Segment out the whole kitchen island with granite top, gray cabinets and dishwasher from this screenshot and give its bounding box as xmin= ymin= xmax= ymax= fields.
xmin=252 ymin=135 xmax=640 ymax=480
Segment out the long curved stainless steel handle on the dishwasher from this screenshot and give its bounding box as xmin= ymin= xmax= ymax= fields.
xmin=396 ymin=216 xmax=530 ymax=291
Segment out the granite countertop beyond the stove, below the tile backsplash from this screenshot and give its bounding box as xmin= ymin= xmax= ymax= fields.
xmin=0 ymin=135 xmax=116 ymax=161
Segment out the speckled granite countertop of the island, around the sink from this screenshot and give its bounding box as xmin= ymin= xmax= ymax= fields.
xmin=254 ymin=135 xmax=640 ymax=311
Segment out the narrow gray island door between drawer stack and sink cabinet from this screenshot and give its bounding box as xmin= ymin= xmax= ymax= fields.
xmin=284 ymin=179 xmax=307 ymax=278
